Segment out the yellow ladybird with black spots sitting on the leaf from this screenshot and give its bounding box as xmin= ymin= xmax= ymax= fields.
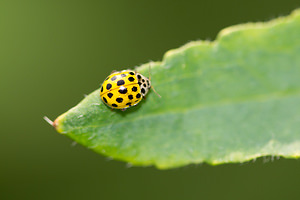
xmin=100 ymin=70 xmax=155 ymax=111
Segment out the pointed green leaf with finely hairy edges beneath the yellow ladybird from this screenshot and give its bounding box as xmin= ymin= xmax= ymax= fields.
xmin=54 ymin=10 xmax=300 ymax=169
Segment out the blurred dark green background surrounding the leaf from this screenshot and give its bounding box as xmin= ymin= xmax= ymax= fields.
xmin=0 ymin=0 xmax=300 ymax=200
